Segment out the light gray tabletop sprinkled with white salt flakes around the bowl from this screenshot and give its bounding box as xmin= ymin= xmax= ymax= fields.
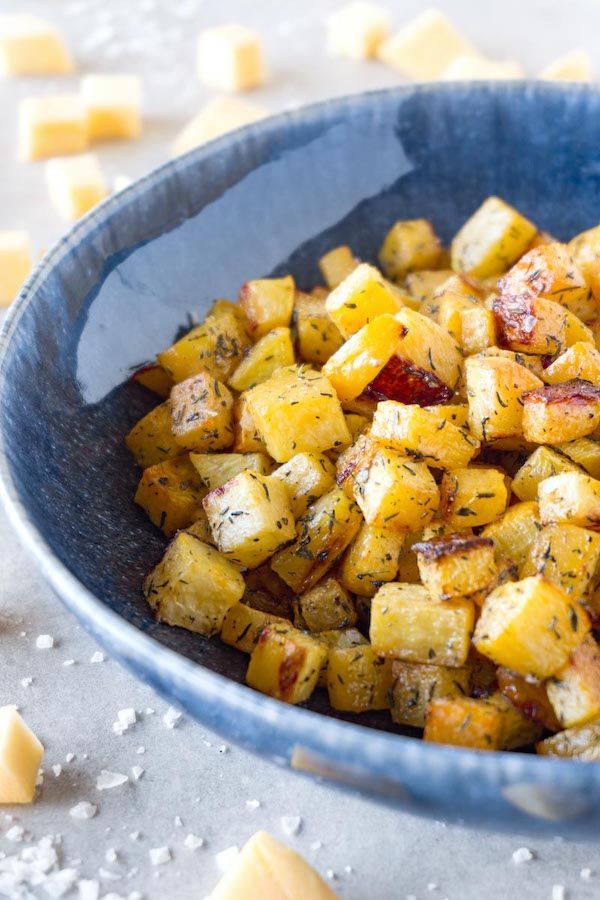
xmin=0 ymin=0 xmax=600 ymax=900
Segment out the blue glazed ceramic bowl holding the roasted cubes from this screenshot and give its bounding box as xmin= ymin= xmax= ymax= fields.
xmin=0 ymin=84 xmax=600 ymax=836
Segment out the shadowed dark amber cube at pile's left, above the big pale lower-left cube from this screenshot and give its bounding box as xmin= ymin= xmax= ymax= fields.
xmin=134 ymin=454 xmax=206 ymax=537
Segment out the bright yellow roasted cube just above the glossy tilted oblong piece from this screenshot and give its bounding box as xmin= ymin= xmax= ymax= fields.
xmin=325 ymin=263 xmax=402 ymax=338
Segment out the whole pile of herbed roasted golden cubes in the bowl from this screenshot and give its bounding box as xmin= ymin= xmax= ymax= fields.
xmin=126 ymin=197 xmax=600 ymax=760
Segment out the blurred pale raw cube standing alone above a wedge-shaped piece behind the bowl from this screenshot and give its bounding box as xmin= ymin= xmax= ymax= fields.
xmin=198 ymin=24 xmax=266 ymax=91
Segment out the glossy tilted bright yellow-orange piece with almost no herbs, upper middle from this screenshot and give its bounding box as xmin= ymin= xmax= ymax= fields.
xmin=323 ymin=314 xmax=403 ymax=401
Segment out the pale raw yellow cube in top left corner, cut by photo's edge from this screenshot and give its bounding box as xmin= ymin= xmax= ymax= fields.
xmin=0 ymin=15 xmax=73 ymax=75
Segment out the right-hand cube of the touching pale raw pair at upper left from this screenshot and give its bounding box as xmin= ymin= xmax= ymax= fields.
xmin=81 ymin=75 xmax=142 ymax=141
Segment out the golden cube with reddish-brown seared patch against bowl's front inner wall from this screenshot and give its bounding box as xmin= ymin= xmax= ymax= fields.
xmin=246 ymin=625 xmax=327 ymax=703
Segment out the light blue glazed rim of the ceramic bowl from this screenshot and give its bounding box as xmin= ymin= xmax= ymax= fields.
xmin=0 ymin=81 xmax=600 ymax=786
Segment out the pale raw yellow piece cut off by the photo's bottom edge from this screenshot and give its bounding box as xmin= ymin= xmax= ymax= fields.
xmin=208 ymin=831 xmax=336 ymax=900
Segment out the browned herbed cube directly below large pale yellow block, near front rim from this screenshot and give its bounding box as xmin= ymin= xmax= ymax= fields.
xmin=392 ymin=660 xmax=471 ymax=728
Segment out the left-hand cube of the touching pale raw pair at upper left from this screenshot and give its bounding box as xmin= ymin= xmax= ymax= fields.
xmin=19 ymin=94 xmax=88 ymax=160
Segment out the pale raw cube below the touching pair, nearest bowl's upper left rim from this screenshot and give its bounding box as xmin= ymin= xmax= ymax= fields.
xmin=46 ymin=153 xmax=108 ymax=222
